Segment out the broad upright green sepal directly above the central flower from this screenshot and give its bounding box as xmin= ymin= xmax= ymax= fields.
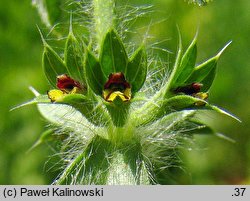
xmin=100 ymin=30 xmax=128 ymax=79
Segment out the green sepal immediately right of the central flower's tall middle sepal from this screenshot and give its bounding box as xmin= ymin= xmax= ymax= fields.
xmin=125 ymin=46 xmax=147 ymax=94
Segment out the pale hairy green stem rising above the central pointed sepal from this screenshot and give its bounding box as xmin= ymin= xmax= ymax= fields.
xmin=93 ymin=0 xmax=115 ymax=50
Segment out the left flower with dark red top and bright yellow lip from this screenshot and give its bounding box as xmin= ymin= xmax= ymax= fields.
xmin=47 ymin=74 xmax=84 ymax=102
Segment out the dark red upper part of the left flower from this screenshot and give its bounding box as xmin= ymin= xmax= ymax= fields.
xmin=56 ymin=74 xmax=83 ymax=92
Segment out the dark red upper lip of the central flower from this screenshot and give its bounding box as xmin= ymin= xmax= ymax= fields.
xmin=104 ymin=72 xmax=131 ymax=89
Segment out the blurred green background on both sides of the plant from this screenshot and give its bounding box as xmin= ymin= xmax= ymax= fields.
xmin=0 ymin=0 xmax=250 ymax=184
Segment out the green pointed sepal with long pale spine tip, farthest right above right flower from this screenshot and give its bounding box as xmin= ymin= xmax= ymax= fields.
xmin=186 ymin=42 xmax=231 ymax=91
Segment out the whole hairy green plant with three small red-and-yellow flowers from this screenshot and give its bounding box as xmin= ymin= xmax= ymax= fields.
xmin=15 ymin=0 xmax=238 ymax=184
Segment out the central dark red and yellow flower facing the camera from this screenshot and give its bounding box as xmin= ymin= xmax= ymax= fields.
xmin=103 ymin=72 xmax=131 ymax=102
